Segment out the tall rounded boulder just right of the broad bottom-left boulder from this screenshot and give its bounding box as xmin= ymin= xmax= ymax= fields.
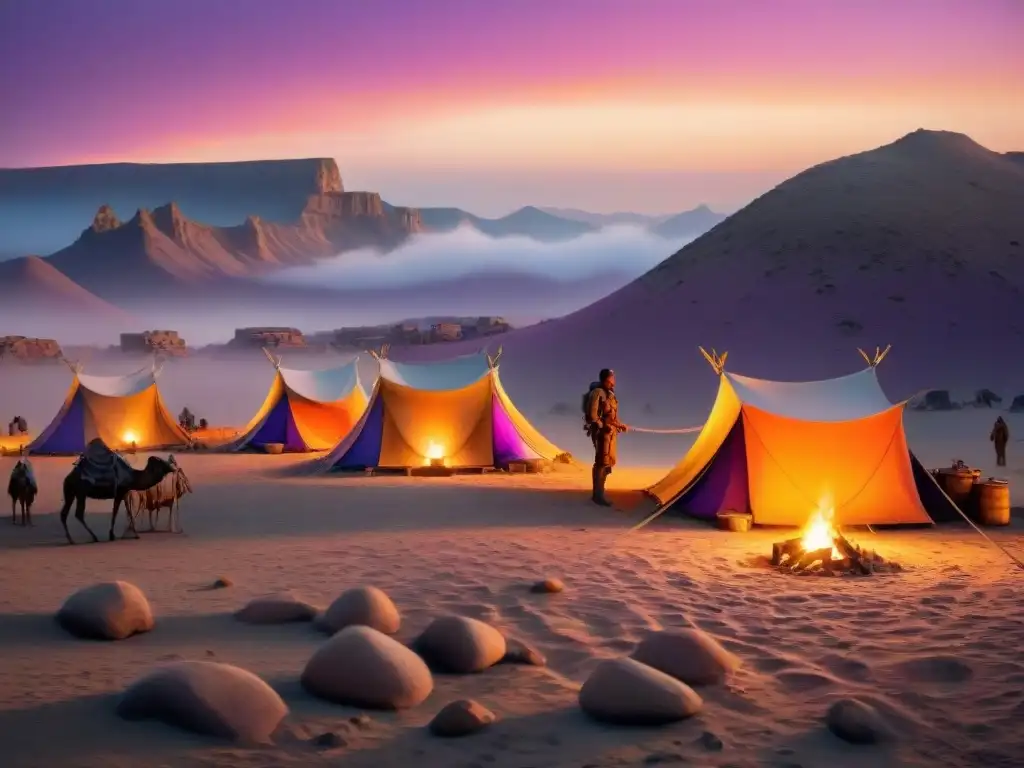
xmin=301 ymin=627 xmax=434 ymax=710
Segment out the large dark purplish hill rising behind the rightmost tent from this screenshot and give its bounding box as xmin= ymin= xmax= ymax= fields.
xmin=409 ymin=130 xmax=1024 ymax=415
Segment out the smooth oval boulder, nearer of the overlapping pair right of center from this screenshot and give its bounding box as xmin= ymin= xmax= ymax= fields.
xmin=580 ymin=658 xmax=703 ymax=725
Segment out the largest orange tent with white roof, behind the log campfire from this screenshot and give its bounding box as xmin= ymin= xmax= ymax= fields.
xmin=647 ymin=355 xmax=958 ymax=525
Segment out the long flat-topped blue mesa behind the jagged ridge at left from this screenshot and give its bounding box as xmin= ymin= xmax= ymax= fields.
xmin=0 ymin=158 xmax=344 ymax=253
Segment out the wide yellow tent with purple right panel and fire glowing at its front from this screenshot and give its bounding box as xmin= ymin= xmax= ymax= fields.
xmin=323 ymin=353 xmax=562 ymax=471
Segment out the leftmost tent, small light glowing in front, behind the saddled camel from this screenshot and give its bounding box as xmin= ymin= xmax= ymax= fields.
xmin=28 ymin=366 xmax=189 ymax=456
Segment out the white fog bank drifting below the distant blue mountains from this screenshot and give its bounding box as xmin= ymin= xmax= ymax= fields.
xmin=260 ymin=226 xmax=690 ymax=290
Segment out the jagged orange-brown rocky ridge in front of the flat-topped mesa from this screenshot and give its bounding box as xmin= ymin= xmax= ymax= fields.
xmin=48 ymin=191 xmax=422 ymax=300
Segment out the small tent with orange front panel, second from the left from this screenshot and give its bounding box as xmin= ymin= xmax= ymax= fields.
xmin=227 ymin=352 xmax=367 ymax=453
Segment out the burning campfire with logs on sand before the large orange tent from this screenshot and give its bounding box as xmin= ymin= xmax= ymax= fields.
xmin=771 ymin=502 xmax=899 ymax=575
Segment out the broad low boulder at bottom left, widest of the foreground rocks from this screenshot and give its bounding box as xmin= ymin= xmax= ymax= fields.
xmin=117 ymin=662 xmax=288 ymax=743
